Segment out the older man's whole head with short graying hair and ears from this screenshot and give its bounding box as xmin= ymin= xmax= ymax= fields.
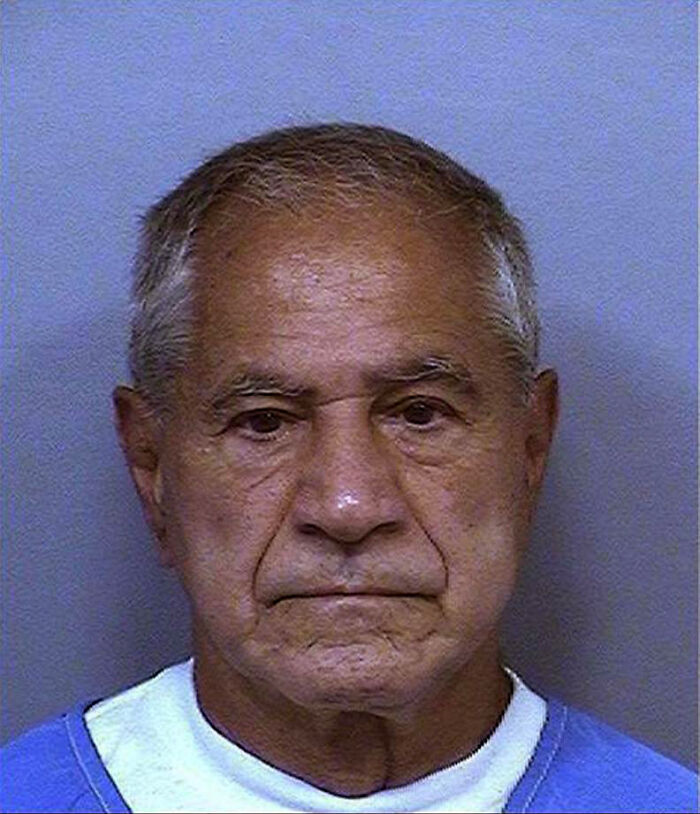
xmin=115 ymin=125 xmax=556 ymax=711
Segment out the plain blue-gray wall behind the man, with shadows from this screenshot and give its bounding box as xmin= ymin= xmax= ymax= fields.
xmin=2 ymin=0 xmax=697 ymax=764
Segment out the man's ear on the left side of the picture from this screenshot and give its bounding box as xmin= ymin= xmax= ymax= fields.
xmin=112 ymin=386 xmax=173 ymax=566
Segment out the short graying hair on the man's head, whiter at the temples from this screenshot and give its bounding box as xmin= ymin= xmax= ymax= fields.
xmin=129 ymin=123 xmax=539 ymax=417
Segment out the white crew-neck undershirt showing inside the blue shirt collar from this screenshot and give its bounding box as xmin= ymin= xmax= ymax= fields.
xmin=85 ymin=659 xmax=546 ymax=813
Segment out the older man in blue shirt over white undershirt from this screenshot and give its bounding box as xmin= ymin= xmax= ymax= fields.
xmin=3 ymin=125 xmax=696 ymax=812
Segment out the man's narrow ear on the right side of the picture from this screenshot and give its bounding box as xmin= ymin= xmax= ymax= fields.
xmin=525 ymin=369 xmax=559 ymax=500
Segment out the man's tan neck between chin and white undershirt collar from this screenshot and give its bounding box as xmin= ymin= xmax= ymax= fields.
xmin=195 ymin=636 xmax=511 ymax=797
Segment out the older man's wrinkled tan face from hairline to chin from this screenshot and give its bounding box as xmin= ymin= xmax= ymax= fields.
xmin=123 ymin=205 xmax=551 ymax=709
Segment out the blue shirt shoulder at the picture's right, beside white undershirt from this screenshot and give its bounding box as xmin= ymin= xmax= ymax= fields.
xmin=508 ymin=701 xmax=698 ymax=812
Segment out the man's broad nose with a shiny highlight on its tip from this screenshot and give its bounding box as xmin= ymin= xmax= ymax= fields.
xmin=293 ymin=416 xmax=407 ymax=544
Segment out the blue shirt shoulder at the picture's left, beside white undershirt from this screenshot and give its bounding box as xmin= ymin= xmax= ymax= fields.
xmin=0 ymin=705 xmax=128 ymax=812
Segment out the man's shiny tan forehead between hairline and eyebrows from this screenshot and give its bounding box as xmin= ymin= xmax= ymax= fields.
xmin=192 ymin=201 xmax=500 ymax=396
